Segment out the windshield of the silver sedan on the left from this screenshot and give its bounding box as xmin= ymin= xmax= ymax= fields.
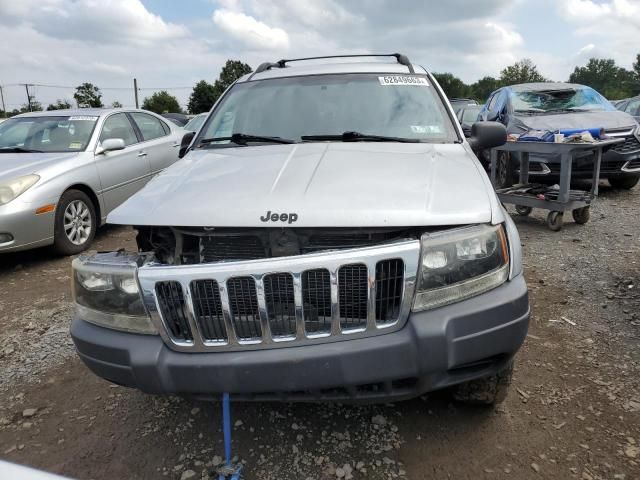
xmin=0 ymin=115 xmax=98 ymax=152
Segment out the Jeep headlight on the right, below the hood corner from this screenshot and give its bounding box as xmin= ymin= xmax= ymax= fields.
xmin=413 ymin=225 xmax=509 ymax=311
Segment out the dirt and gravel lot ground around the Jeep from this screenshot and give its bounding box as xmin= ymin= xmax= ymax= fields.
xmin=0 ymin=187 xmax=640 ymax=480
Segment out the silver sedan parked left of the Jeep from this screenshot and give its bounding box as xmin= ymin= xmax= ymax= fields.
xmin=0 ymin=108 xmax=184 ymax=255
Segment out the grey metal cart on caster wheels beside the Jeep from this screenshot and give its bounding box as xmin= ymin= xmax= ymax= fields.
xmin=491 ymin=138 xmax=623 ymax=232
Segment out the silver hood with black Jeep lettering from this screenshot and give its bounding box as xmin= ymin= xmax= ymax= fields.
xmin=107 ymin=142 xmax=497 ymax=227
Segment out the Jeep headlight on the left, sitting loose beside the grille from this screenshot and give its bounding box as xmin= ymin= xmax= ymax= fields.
xmin=72 ymin=253 xmax=158 ymax=334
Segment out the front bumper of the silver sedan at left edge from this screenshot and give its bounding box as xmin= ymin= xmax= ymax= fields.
xmin=0 ymin=199 xmax=55 ymax=252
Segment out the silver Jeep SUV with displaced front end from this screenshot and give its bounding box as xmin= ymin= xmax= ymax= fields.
xmin=71 ymin=54 xmax=529 ymax=404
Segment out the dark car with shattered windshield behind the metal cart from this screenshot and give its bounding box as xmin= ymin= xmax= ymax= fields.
xmin=480 ymin=82 xmax=640 ymax=189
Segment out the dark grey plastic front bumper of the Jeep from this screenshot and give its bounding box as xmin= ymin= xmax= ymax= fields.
xmin=71 ymin=275 xmax=529 ymax=401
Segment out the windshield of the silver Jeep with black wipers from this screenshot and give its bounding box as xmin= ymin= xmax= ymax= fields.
xmin=200 ymin=74 xmax=457 ymax=147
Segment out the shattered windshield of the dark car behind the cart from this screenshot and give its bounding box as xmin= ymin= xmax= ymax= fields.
xmin=511 ymin=87 xmax=615 ymax=113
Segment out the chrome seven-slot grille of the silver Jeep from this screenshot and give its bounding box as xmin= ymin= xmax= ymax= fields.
xmin=138 ymin=240 xmax=420 ymax=351
